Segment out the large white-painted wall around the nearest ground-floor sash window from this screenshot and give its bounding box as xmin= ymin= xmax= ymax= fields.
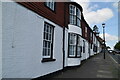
xmin=2 ymin=3 xmax=63 ymax=78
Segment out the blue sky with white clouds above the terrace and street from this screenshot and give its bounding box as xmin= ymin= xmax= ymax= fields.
xmin=74 ymin=0 xmax=118 ymax=49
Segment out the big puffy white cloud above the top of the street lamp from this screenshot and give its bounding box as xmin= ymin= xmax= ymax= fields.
xmin=85 ymin=8 xmax=113 ymax=24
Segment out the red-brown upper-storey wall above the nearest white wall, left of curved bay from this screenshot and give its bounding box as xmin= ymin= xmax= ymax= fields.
xmin=19 ymin=2 xmax=65 ymax=27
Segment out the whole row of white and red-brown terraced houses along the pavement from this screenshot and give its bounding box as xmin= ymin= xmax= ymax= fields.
xmin=2 ymin=1 xmax=101 ymax=78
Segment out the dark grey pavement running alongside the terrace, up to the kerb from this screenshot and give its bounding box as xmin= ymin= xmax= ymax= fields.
xmin=37 ymin=53 xmax=120 ymax=80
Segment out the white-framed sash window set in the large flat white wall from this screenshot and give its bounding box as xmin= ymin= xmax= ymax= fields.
xmin=43 ymin=22 xmax=54 ymax=58
